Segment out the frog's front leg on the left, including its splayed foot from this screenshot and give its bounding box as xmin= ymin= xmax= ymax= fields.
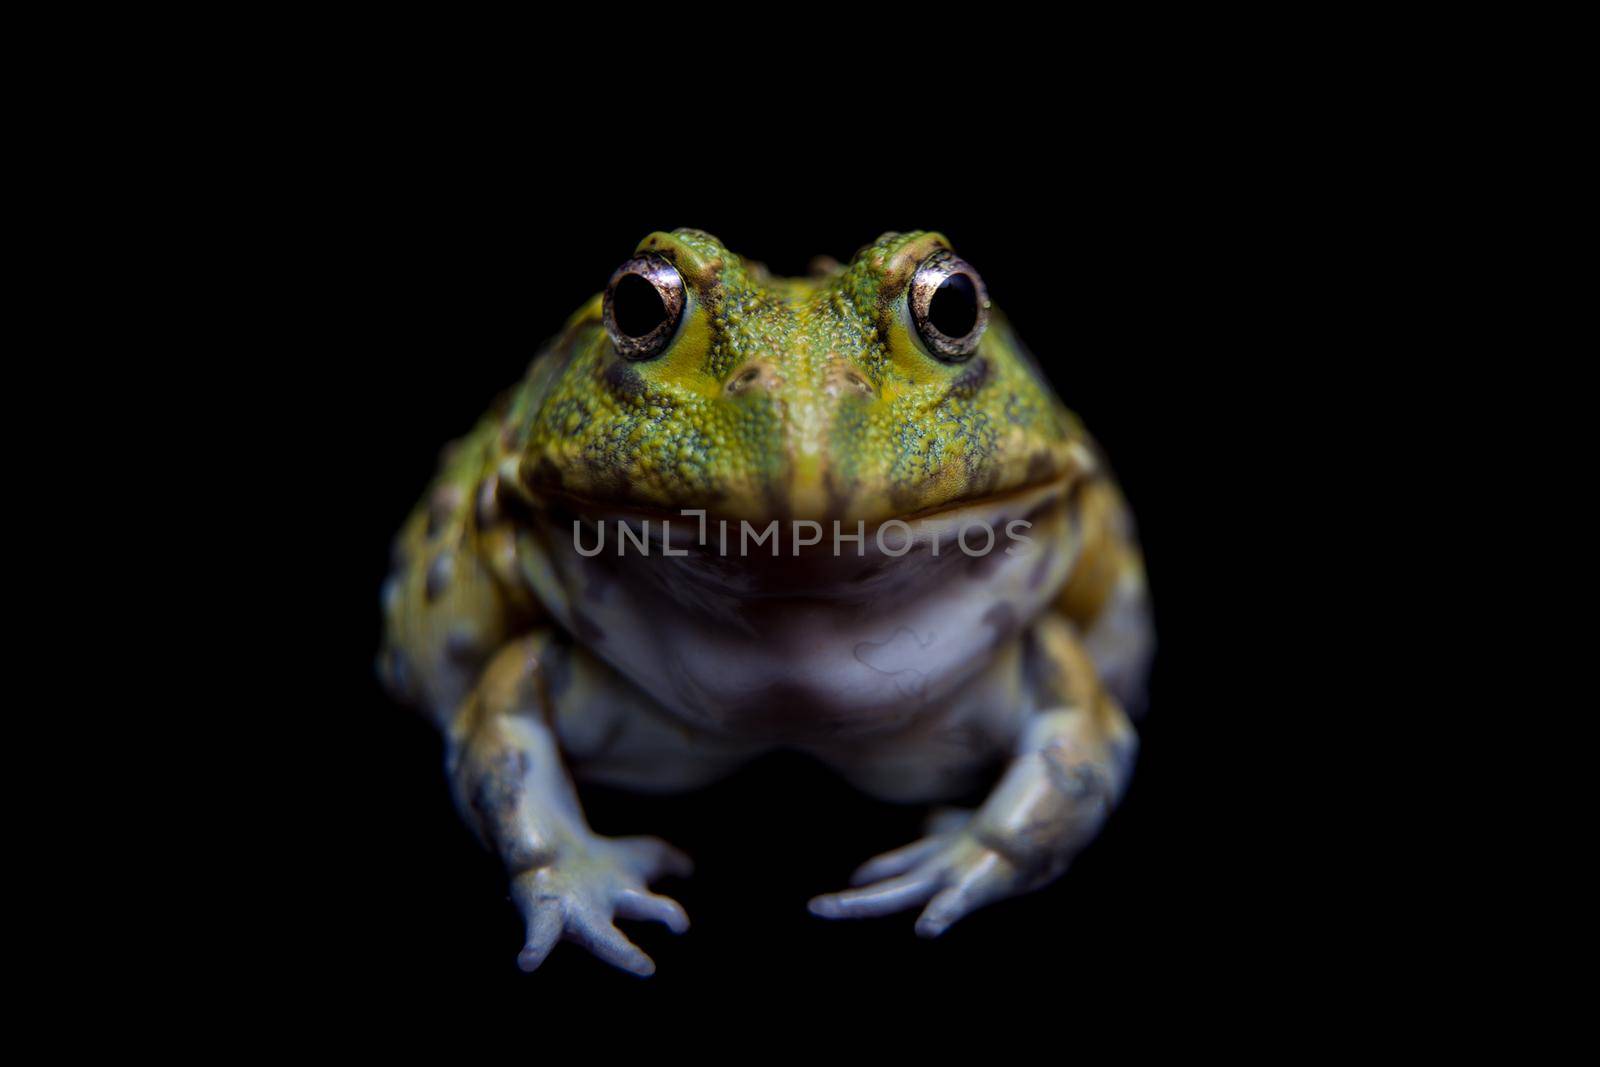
xmin=450 ymin=630 xmax=690 ymax=976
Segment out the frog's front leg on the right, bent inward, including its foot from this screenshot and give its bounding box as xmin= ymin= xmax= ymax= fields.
xmin=810 ymin=614 xmax=1138 ymax=937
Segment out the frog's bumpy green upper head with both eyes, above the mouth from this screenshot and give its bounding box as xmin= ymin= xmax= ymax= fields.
xmin=509 ymin=230 xmax=1088 ymax=523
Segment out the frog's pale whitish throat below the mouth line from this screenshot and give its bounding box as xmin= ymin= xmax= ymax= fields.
xmin=528 ymin=488 xmax=1077 ymax=744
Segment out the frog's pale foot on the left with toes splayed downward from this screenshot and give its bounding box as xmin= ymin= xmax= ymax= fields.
xmin=512 ymin=835 xmax=691 ymax=977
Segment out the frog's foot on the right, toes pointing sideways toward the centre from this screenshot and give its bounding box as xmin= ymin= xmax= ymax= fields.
xmin=810 ymin=809 xmax=1059 ymax=937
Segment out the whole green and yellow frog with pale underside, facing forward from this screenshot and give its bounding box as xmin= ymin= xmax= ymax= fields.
xmin=378 ymin=229 xmax=1155 ymax=976
